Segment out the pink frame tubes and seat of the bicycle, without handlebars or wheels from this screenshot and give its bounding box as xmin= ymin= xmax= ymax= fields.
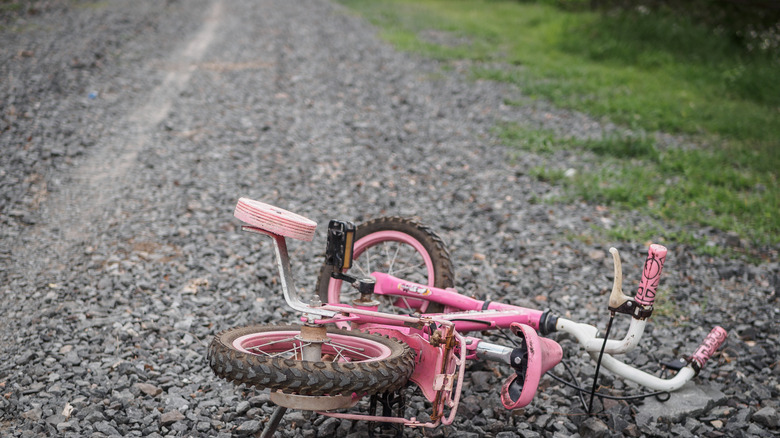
xmin=314 ymin=288 xmax=562 ymax=420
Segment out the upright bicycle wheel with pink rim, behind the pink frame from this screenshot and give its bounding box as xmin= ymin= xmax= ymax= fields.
xmin=317 ymin=217 xmax=455 ymax=313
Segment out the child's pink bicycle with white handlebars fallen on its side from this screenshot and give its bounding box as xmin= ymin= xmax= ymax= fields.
xmin=208 ymin=198 xmax=726 ymax=436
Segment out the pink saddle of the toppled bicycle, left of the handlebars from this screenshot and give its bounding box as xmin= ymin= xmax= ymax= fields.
xmin=501 ymin=323 xmax=563 ymax=409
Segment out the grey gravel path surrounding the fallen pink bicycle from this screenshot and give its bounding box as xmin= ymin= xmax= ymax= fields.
xmin=0 ymin=0 xmax=780 ymax=437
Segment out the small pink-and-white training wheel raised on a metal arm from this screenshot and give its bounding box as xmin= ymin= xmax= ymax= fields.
xmin=233 ymin=198 xmax=317 ymax=242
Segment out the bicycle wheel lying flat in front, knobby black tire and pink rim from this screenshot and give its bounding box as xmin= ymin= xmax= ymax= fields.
xmin=208 ymin=325 xmax=414 ymax=396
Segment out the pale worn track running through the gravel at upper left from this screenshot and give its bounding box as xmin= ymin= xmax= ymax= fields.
xmin=0 ymin=0 xmax=224 ymax=346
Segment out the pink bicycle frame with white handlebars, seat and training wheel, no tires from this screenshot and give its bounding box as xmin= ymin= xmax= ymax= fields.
xmin=216 ymin=201 xmax=726 ymax=427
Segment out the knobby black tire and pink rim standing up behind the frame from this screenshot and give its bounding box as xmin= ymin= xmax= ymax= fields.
xmin=317 ymin=217 xmax=455 ymax=313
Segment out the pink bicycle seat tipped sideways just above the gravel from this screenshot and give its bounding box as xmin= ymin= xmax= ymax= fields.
xmin=501 ymin=322 xmax=563 ymax=409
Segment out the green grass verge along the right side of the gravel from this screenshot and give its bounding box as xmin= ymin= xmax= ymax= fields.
xmin=342 ymin=0 xmax=780 ymax=250
